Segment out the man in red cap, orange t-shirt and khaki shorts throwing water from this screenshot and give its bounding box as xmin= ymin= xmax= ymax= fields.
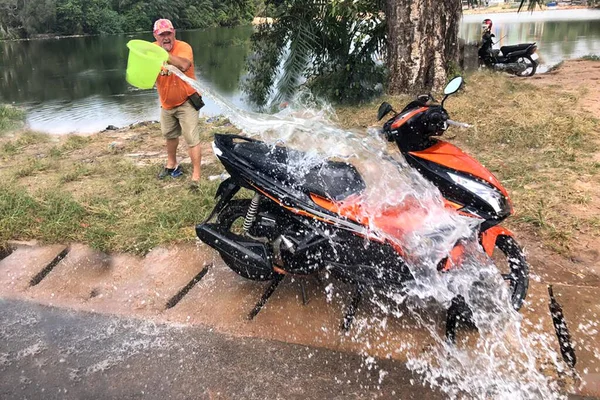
xmin=153 ymin=19 xmax=202 ymax=188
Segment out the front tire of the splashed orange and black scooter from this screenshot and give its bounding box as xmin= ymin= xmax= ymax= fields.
xmin=492 ymin=235 xmax=529 ymax=311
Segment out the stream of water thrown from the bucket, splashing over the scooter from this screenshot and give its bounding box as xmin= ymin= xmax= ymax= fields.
xmin=170 ymin=67 xmax=563 ymax=399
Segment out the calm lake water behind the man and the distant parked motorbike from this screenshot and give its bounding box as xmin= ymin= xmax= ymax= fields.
xmin=0 ymin=10 xmax=600 ymax=133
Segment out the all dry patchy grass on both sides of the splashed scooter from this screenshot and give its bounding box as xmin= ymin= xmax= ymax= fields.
xmin=0 ymin=67 xmax=600 ymax=254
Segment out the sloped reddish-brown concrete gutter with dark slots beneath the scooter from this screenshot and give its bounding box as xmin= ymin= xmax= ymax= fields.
xmin=0 ymin=245 xmax=600 ymax=398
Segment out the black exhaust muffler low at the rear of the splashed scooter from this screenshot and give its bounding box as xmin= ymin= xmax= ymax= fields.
xmin=196 ymin=223 xmax=273 ymax=271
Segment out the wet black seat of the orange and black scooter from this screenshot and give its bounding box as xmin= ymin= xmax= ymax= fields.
xmin=233 ymin=142 xmax=366 ymax=201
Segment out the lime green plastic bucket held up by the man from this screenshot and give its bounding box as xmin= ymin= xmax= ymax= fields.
xmin=125 ymin=40 xmax=169 ymax=89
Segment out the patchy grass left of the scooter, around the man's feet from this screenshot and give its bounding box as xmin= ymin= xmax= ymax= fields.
xmin=0 ymin=120 xmax=222 ymax=254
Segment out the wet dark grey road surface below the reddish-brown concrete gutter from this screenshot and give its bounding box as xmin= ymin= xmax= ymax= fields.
xmin=0 ymin=300 xmax=443 ymax=400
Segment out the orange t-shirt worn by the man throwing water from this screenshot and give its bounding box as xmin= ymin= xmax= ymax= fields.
xmin=154 ymin=40 xmax=196 ymax=110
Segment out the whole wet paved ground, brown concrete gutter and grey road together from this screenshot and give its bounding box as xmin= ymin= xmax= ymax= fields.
xmin=0 ymin=244 xmax=600 ymax=400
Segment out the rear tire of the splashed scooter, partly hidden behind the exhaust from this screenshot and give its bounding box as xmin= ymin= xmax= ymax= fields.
xmin=217 ymin=199 xmax=279 ymax=281
